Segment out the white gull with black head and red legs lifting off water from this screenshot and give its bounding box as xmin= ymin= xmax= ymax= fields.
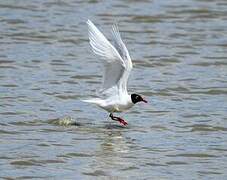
xmin=83 ymin=20 xmax=147 ymax=125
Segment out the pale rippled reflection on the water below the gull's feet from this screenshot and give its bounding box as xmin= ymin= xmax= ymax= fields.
xmin=88 ymin=124 xmax=136 ymax=173
